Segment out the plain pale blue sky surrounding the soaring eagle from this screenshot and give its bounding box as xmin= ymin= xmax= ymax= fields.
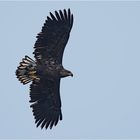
xmin=0 ymin=1 xmax=140 ymax=139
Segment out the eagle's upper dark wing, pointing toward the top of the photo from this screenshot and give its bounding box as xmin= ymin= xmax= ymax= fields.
xmin=34 ymin=9 xmax=73 ymax=64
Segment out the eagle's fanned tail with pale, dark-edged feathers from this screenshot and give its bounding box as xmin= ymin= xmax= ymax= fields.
xmin=16 ymin=56 xmax=39 ymax=85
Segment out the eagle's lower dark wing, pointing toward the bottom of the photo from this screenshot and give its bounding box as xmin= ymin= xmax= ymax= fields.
xmin=30 ymin=78 xmax=62 ymax=129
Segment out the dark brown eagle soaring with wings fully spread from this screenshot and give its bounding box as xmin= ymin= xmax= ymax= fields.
xmin=16 ymin=9 xmax=73 ymax=129
